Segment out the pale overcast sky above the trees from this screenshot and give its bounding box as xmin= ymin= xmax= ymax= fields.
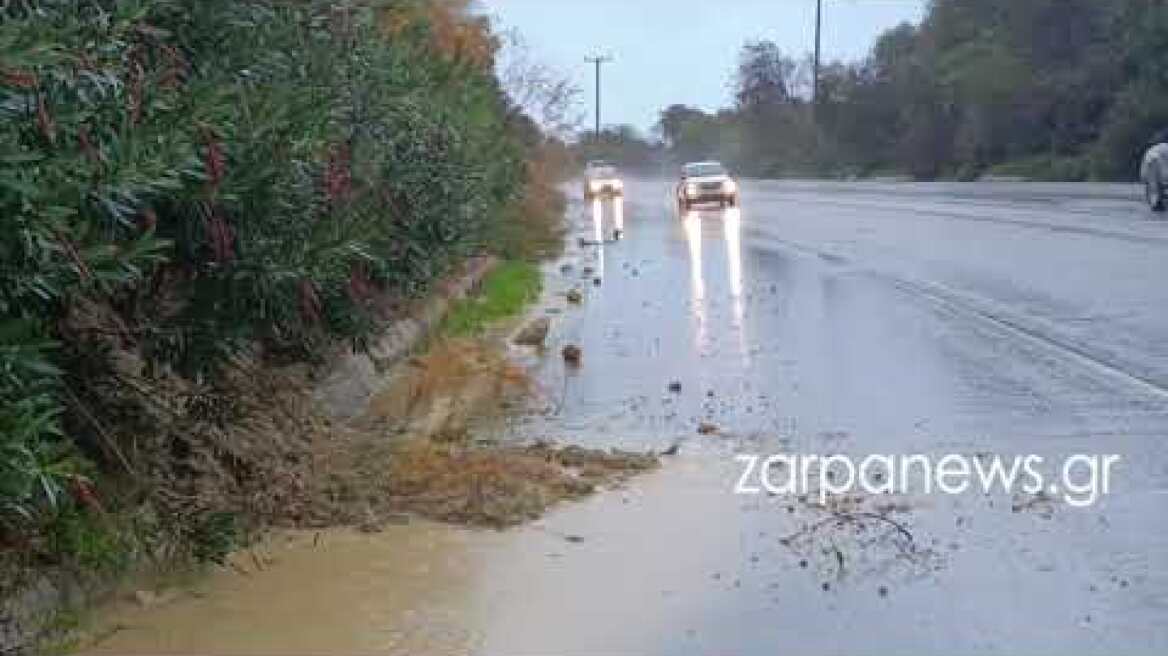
xmin=480 ymin=0 xmax=926 ymax=130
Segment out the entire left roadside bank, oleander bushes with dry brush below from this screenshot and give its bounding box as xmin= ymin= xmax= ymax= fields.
xmin=0 ymin=0 xmax=574 ymax=652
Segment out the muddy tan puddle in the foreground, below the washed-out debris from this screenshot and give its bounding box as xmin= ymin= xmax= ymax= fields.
xmin=86 ymin=463 xmax=732 ymax=655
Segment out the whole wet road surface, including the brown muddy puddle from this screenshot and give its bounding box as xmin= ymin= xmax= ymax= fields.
xmin=88 ymin=180 xmax=1168 ymax=655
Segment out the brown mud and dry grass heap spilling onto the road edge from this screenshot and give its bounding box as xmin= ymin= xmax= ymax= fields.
xmin=296 ymin=339 xmax=658 ymax=531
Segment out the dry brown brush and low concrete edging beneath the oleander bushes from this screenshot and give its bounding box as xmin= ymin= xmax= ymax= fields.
xmin=0 ymin=258 xmax=495 ymax=654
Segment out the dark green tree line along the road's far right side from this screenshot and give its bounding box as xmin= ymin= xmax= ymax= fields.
xmin=602 ymin=0 xmax=1168 ymax=180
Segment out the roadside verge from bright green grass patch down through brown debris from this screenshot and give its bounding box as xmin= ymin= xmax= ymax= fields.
xmin=25 ymin=242 xmax=659 ymax=648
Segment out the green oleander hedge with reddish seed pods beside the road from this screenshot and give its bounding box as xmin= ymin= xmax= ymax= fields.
xmin=0 ymin=0 xmax=554 ymax=562
